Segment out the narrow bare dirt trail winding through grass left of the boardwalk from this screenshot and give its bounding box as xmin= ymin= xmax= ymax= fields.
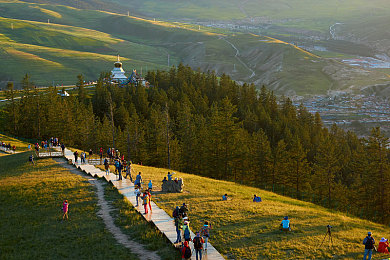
xmin=54 ymin=158 xmax=161 ymax=260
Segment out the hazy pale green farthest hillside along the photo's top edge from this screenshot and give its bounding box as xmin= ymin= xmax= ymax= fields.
xmin=20 ymin=0 xmax=390 ymax=31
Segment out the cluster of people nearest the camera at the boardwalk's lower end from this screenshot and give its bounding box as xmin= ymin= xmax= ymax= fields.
xmin=172 ymin=203 xmax=210 ymax=260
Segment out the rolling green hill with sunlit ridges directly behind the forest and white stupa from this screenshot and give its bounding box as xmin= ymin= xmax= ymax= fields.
xmin=0 ymin=1 xmax=387 ymax=95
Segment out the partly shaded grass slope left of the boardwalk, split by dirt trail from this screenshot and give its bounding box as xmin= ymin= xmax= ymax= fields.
xmin=0 ymin=151 xmax=178 ymax=259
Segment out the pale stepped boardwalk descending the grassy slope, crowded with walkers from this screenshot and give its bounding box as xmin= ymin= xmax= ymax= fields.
xmin=64 ymin=149 xmax=225 ymax=260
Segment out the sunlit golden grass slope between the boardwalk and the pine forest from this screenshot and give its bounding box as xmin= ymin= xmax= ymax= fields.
xmin=123 ymin=165 xmax=390 ymax=259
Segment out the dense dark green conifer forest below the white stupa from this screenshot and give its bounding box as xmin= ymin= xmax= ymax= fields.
xmin=5 ymin=65 xmax=390 ymax=223
